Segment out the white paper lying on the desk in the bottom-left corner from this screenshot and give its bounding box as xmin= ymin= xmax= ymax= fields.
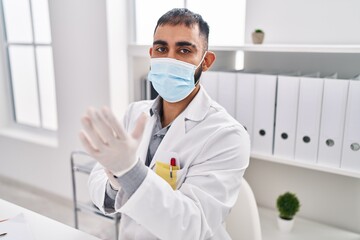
xmin=0 ymin=213 xmax=35 ymax=240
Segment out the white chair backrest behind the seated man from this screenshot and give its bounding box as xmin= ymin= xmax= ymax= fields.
xmin=226 ymin=178 xmax=261 ymax=240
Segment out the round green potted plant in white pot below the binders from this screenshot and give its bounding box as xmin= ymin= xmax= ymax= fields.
xmin=276 ymin=192 xmax=300 ymax=232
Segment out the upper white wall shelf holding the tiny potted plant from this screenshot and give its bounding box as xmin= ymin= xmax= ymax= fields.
xmin=128 ymin=44 xmax=360 ymax=57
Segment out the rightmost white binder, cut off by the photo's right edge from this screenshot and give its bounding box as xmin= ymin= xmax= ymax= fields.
xmin=341 ymin=80 xmax=360 ymax=172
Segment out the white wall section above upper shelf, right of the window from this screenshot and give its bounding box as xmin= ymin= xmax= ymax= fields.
xmin=245 ymin=0 xmax=360 ymax=44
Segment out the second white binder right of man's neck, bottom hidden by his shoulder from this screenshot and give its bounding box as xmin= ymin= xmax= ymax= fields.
xmin=218 ymin=72 xmax=236 ymax=118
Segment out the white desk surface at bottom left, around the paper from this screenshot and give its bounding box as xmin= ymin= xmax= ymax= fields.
xmin=0 ymin=199 xmax=100 ymax=240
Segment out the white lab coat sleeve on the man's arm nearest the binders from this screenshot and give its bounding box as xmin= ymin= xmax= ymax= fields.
xmin=115 ymin=126 xmax=250 ymax=240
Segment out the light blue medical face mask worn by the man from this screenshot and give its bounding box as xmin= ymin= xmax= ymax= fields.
xmin=148 ymin=52 xmax=206 ymax=103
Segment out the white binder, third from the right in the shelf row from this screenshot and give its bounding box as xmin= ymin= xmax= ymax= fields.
xmin=295 ymin=77 xmax=324 ymax=163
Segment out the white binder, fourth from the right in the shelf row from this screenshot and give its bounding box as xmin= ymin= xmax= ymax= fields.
xmin=274 ymin=75 xmax=300 ymax=159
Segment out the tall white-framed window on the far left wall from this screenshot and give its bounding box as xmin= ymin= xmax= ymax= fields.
xmin=0 ymin=0 xmax=57 ymax=131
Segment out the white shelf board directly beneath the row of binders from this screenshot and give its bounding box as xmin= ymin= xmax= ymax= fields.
xmin=251 ymin=153 xmax=360 ymax=178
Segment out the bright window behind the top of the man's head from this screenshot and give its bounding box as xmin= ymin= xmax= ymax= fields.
xmin=134 ymin=0 xmax=246 ymax=46
